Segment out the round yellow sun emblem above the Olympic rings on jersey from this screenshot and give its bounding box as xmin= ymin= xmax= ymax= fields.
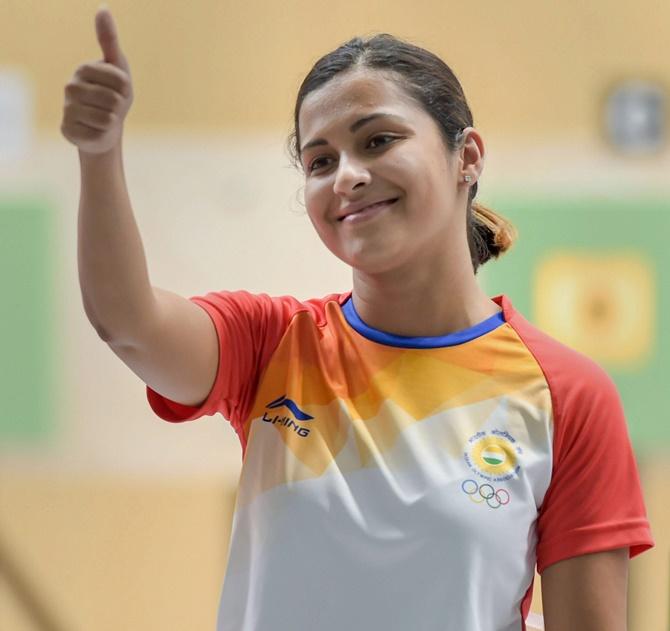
xmin=463 ymin=429 xmax=523 ymax=482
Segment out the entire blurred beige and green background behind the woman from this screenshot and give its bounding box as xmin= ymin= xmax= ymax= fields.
xmin=0 ymin=0 xmax=670 ymax=631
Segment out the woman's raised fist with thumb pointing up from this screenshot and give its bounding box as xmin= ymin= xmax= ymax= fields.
xmin=61 ymin=9 xmax=133 ymax=154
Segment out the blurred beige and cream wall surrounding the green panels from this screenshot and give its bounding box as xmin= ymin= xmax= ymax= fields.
xmin=0 ymin=0 xmax=670 ymax=631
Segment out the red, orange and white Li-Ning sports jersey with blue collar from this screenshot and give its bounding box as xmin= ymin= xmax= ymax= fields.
xmin=147 ymin=290 xmax=654 ymax=631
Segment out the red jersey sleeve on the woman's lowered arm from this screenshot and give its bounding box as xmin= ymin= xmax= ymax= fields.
xmin=537 ymin=353 xmax=654 ymax=574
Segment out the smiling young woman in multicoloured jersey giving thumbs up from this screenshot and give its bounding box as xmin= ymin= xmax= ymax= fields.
xmin=62 ymin=6 xmax=653 ymax=631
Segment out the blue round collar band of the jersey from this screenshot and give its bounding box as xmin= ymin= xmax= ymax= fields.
xmin=341 ymin=292 xmax=506 ymax=348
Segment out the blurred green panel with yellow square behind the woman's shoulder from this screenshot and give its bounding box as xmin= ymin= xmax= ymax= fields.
xmin=479 ymin=195 xmax=670 ymax=450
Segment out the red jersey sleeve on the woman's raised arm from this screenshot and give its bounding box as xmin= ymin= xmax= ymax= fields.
xmin=146 ymin=290 xmax=295 ymax=434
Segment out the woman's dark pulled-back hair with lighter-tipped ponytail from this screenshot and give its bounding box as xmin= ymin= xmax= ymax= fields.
xmin=288 ymin=33 xmax=517 ymax=274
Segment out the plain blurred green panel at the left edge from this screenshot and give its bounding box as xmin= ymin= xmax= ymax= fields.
xmin=0 ymin=197 xmax=63 ymax=443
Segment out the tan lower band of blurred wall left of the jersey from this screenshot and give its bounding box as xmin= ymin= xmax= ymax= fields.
xmin=0 ymin=473 xmax=234 ymax=631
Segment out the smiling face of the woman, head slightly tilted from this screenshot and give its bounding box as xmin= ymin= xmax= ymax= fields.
xmin=299 ymin=70 xmax=470 ymax=273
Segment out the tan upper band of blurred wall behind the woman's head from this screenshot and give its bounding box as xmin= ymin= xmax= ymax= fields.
xmin=0 ymin=0 xmax=670 ymax=139
